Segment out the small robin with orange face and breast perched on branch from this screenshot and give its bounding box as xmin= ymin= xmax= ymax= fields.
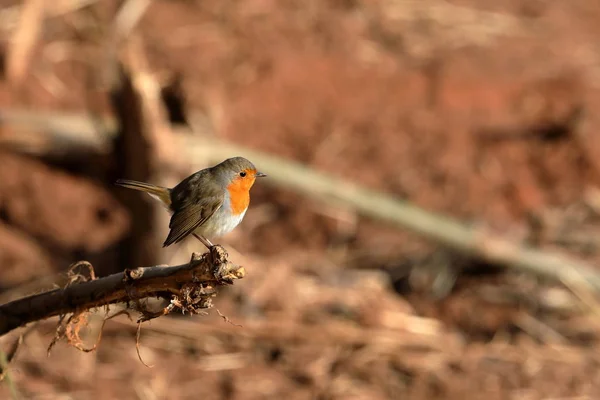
xmin=115 ymin=157 xmax=266 ymax=250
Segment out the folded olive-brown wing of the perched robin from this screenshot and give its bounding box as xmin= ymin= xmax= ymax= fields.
xmin=163 ymin=176 xmax=224 ymax=247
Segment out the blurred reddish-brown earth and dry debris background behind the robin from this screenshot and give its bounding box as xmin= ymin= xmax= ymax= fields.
xmin=0 ymin=0 xmax=600 ymax=400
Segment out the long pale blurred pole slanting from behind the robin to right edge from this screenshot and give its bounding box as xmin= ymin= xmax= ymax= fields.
xmin=0 ymin=112 xmax=600 ymax=292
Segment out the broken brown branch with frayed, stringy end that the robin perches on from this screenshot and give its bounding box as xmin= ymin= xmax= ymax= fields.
xmin=0 ymin=246 xmax=245 ymax=335
